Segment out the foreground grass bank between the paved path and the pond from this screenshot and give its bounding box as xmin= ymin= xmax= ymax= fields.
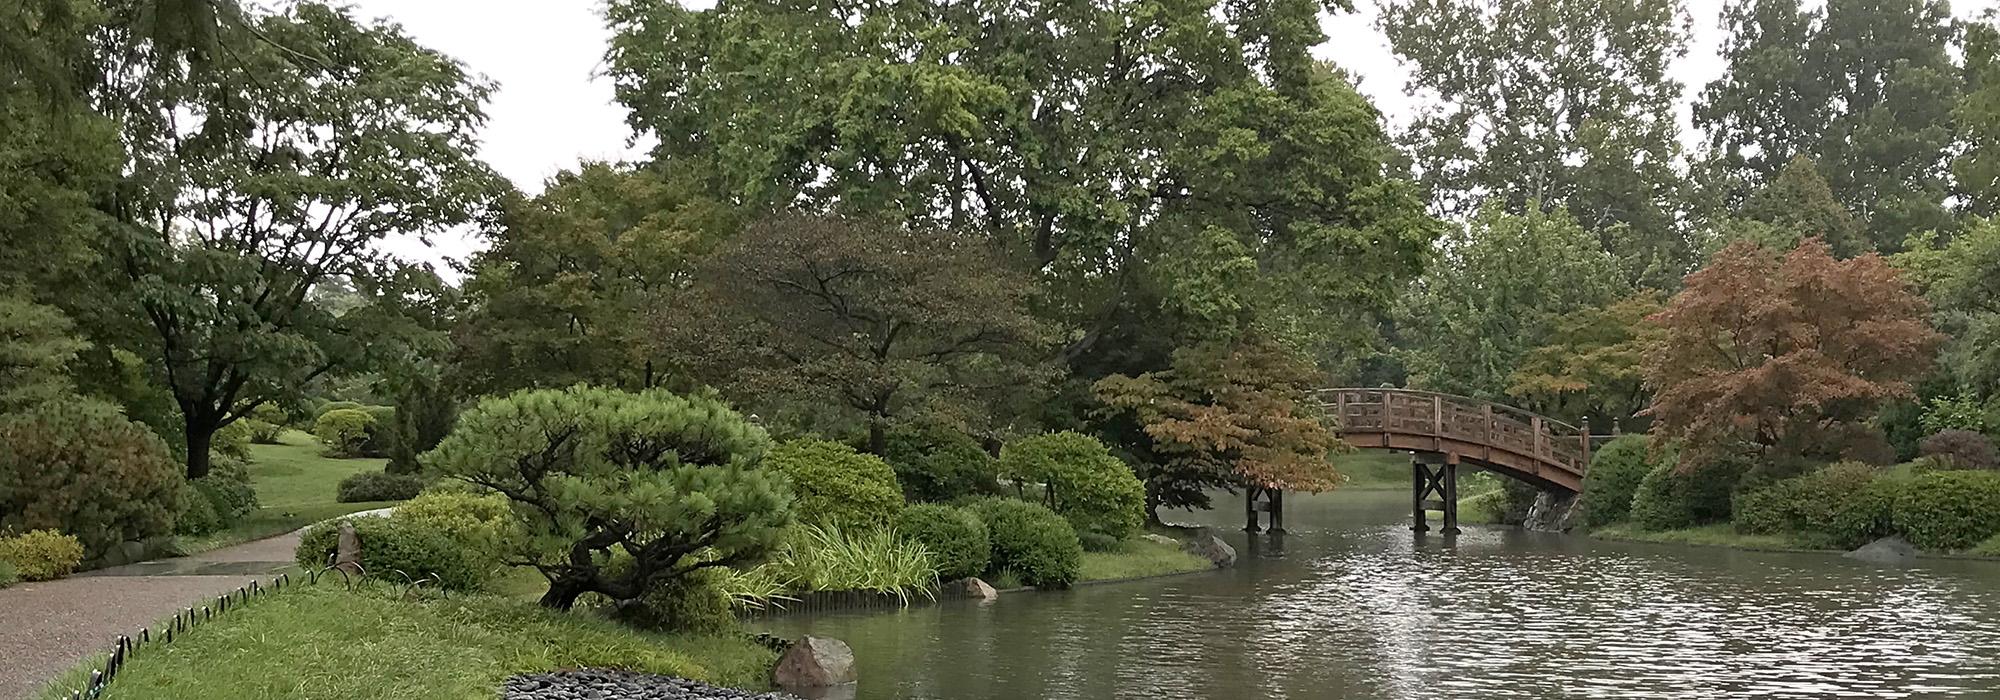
xmin=42 ymin=582 xmax=774 ymax=700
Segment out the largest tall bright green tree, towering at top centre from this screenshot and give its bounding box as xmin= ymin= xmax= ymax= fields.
xmin=608 ymin=0 xmax=1438 ymax=394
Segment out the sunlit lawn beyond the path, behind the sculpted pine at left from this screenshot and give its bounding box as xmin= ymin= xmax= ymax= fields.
xmin=180 ymin=430 xmax=408 ymax=554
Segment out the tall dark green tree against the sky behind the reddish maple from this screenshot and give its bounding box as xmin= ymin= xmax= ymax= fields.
xmin=1694 ymin=0 xmax=1962 ymax=252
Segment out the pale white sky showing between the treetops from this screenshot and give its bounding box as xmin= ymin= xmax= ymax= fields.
xmin=360 ymin=0 xmax=2000 ymax=274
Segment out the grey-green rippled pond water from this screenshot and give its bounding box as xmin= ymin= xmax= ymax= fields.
xmin=754 ymin=492 xmax=2000 ymax=700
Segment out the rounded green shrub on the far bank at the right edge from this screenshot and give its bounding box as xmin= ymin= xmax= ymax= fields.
xmin=1890 ymin=470 xmax=2000 ymax=552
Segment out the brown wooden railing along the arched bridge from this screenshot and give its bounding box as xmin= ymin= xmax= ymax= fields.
xmin=1320 ymin=388 xmax=1590 ymax=476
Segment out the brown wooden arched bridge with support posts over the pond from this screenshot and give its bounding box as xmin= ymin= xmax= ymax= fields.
xmin=1246 ymin=388 xmax=1592 ymax=532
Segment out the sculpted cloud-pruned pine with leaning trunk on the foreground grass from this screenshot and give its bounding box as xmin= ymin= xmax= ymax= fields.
xmin=426 ymin=386 xmax=792 ymax=610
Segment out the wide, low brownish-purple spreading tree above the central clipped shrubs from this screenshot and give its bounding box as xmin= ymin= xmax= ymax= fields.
xmin=656 ymin=214 xmax=1048 ymax=456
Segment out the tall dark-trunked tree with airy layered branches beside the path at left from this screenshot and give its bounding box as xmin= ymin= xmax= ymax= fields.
xmin=98 ymin=4 xmax=494 ymax=476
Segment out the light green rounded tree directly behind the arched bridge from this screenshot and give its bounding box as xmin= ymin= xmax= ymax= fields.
xmin=1396 ymin=202 xmax=1630 ymax=400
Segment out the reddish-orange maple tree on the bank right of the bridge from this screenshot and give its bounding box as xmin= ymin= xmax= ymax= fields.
xmin=1646 ymin=238 xmax=1940 ymax=456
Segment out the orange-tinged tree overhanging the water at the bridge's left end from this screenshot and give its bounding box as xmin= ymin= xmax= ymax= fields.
xmin=1096 ymin=338 xmax=1346 ymax=522
